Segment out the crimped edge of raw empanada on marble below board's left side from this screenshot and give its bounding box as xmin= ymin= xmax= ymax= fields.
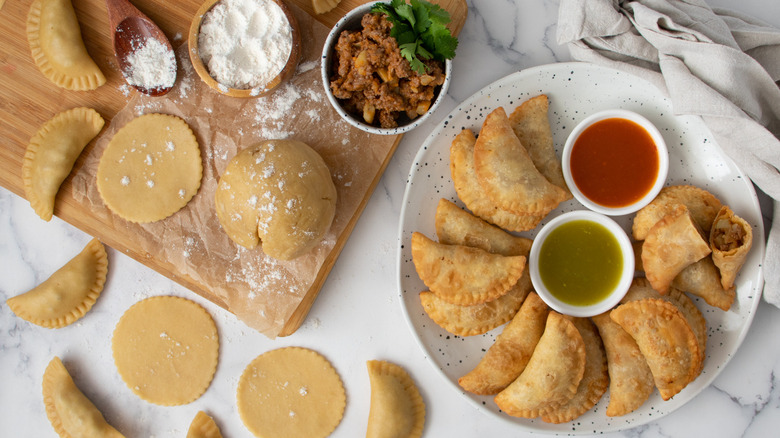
xmin=6 ymin=238 xmax=108 ymax=328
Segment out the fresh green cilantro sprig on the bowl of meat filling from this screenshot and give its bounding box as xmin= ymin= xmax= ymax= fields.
xmin=371 ymin=0 xmax=458 ymax=74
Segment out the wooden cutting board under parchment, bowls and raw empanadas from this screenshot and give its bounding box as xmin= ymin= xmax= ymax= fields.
xmin=0 ymin=0 xmax=467 ymax=336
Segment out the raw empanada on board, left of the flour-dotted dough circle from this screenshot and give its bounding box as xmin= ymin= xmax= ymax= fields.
xmin=22 ymin=107 xmax=105 ymax=221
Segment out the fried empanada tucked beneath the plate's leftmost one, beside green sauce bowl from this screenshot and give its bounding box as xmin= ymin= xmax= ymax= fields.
xmin=420 ymin=266 xmax=533 ymax=336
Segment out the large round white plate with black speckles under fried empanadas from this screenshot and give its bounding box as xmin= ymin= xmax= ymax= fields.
xmin=398 ymin=63 xmax=764 ymax=434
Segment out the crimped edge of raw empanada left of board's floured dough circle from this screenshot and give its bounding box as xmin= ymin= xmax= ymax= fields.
xmin=22 ymin=107 xmax=105 ymax=221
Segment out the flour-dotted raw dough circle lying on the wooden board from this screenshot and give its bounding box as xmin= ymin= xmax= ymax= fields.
xmin=97 ymin=114 xmax=203 ymax=223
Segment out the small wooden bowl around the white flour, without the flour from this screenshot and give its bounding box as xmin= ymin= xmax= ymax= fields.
xmin=187 ymin=0 xmax=301 ymax=97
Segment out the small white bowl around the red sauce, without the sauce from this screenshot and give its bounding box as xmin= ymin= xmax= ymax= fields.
xmin=561 ymin=109 xmax=669 ymax=216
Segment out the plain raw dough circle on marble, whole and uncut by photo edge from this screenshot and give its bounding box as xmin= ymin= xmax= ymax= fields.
xmin=112 ymin=296 xmax=219 ymax=406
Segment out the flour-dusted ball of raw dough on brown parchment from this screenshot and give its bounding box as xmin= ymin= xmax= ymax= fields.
xmin=215 ymin=140 xmax=336 ymax=260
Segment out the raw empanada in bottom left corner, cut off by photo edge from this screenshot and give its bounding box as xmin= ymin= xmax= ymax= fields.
xmin=43 ymin=356 xmax=124 ymax=438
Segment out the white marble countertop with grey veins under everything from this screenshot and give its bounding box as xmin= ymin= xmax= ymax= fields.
xmin=0 ymin=0 xmax=780 ymax=437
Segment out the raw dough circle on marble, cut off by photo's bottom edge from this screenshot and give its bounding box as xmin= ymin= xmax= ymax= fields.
xmin=236 ymin=347 xmax=346 ymax=438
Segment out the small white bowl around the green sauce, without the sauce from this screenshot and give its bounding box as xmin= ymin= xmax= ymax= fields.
xmin=528 ymin=210 xmax=634 ymax=317
